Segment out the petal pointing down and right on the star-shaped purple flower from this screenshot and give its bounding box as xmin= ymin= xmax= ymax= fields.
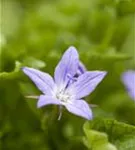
xmin=65 ymin=100 xmax=92 ymax=120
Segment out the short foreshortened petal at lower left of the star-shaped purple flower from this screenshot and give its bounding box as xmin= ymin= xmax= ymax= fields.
xmin=37 ymin=95 xmax=61 ymax=108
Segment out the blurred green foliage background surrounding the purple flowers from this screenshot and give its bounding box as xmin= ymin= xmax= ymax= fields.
xmin=0 ymin=0 xmax=135 ymax=150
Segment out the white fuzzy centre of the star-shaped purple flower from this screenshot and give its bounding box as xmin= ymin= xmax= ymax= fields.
xmin=56 ymin=91 xmax=71 ymax=103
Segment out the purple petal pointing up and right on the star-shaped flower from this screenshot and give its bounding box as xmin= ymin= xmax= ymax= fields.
xmin=72 ymin=71 xmax=106 ymax=99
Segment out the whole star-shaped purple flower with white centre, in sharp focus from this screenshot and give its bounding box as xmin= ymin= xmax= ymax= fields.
xmin=22 ymin=47 xmax=106 ymax=120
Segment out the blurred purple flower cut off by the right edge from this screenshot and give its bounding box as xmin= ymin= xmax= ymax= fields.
xmin=122 ymin=70 xmax=135 ymax=100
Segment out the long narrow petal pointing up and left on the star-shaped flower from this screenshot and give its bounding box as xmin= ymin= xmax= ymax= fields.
xmin=22 ymin=67 xmax=55 ymax=95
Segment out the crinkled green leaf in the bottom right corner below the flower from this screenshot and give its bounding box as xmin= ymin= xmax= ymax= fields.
xmin=84 ymin=119 xmax=135 ymax=150
